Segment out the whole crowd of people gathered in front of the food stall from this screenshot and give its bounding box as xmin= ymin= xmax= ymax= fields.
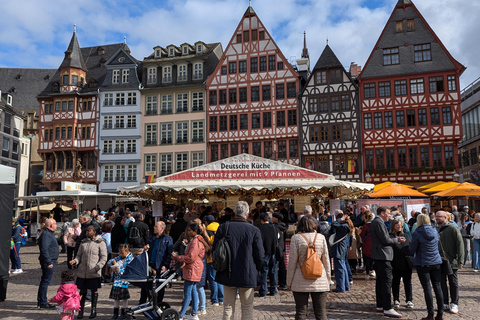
xmin=10 ymin=201 xmax=480 ymax=320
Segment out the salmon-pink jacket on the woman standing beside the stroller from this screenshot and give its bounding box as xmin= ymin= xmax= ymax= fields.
xmin=177 ymin=236 xmax=205 ymax=282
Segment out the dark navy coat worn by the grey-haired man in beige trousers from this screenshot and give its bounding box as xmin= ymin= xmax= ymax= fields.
xmin=213 ymin=218 xmax=265 ymax=288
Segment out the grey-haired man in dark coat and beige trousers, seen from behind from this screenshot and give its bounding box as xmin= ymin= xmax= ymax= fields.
xmin=213 ymin=201 xmax=265 ymax=320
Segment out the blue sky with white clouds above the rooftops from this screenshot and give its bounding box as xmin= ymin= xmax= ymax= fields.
xmin=0 ymin=0 xmax=480 ymax=89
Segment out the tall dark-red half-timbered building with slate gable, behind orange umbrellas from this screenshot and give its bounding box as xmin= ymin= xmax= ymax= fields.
xmin=358 ymin=0 xmax=465 ymax=185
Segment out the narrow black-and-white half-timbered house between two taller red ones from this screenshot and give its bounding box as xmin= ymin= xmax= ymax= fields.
xmin=300 ymin=44 xmax=362 ymax=181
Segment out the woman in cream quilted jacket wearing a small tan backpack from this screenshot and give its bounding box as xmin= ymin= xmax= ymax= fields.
xmin=287 ymin=214 xmax=331 ymax=320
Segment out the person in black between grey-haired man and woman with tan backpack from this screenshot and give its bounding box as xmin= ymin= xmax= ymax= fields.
xmin=258 ymin=212 xmax=278 ymax=297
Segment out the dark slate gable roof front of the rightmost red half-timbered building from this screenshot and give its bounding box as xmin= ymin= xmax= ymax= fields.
xmin=358 ymin=0 xmax=465 ymax=79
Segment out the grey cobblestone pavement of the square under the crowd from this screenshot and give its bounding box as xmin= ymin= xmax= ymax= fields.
xmin=0 ymin=243 xmax=480 ymax=320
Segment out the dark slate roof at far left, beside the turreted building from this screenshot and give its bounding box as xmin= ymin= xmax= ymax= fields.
xmin=0 ymin=68 xmax=57 ymax=113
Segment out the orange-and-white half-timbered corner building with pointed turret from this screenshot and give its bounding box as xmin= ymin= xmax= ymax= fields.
xmin=37 ymin=32 xmax=125 ymax=190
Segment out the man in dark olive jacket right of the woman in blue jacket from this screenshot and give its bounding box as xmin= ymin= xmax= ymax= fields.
xmin=435 ymin=211 xmax=465 ymax=314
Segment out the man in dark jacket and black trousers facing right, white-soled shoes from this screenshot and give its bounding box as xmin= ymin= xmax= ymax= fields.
xmin=370 ymin=207 xmax=405 ymax=318
